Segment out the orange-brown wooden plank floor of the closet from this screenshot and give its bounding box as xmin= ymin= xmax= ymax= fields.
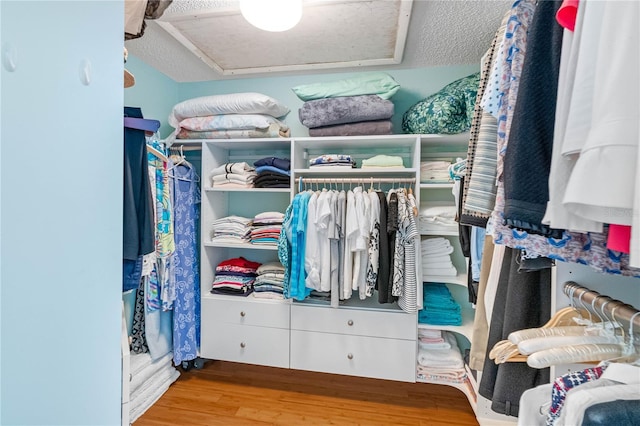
xmin=134 ymin=361 xmax=478 ymax=426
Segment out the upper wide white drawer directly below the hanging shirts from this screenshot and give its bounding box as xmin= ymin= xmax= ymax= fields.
xmin=291 ymin=305 xmax=417 ymax=340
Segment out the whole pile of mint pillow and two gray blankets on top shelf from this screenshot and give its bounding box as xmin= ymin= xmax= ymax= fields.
xmin=293 ymin=72 xmax=400 ymax=136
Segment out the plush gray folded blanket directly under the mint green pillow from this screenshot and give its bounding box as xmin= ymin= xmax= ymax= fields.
xmin=298 ymin=95 xmax=394 ymax=129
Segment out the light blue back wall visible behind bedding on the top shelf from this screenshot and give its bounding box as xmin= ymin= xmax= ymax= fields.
xmin=179 ymin=64 xmax=480 ymax=136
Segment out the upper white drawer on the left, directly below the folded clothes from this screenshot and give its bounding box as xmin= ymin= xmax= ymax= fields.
xmin=202 ymin=297 xmax=291 ymax=330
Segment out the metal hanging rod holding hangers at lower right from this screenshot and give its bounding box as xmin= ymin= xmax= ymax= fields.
xmin=562 ymin=281 xmax=640 ymax=334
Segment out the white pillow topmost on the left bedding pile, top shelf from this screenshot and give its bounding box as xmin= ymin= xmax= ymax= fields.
xmin=169 ymin=92 xmax=289 ymax=129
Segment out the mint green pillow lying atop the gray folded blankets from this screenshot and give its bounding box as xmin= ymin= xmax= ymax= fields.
xmin=291 ymin=72 xmax=400 ymax=101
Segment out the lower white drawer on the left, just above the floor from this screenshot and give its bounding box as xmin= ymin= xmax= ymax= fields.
xmin=200 ymin=324 xmax=289 ymax=368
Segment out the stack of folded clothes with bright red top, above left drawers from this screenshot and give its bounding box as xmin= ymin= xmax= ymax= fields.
xmin=211 ymin=257 xmax=261 ymax=296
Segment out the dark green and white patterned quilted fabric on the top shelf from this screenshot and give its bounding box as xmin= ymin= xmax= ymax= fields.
xmin=402 ymin=73 xmax=480 ymax=134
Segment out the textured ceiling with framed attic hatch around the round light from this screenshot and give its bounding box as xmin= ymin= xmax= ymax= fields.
xmin=126 ymin=0 xmax=512 ymax=82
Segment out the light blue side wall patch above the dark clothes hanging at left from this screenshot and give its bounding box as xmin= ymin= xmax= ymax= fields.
xmin=124 ymin=55 xmax=179 ymax=138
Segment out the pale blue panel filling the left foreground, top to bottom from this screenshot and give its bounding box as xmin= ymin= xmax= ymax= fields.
xmin=0 ymin=0 xmax=124 ymax=425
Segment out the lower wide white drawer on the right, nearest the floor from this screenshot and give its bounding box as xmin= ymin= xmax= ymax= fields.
xmin=291 ymin=330 xmax=416 ymax=382
